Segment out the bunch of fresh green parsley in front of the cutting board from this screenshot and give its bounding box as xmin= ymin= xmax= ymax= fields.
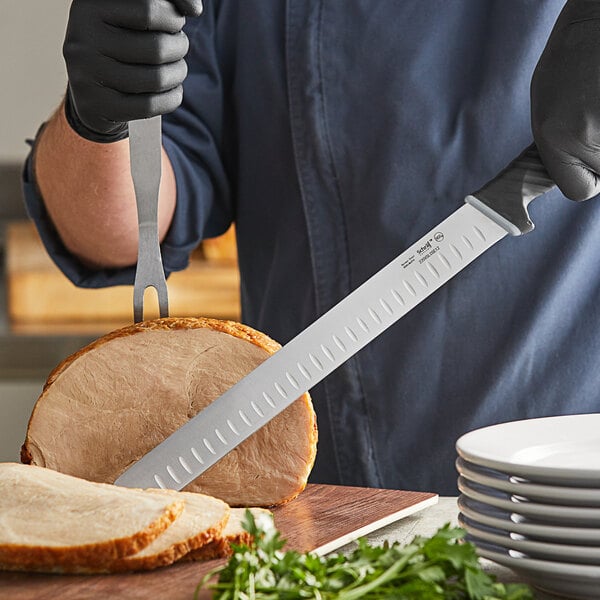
xmin=195 ymin=511 xmax=534 ymax=600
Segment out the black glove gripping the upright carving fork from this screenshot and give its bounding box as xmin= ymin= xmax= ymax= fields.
xmin=63 ymin=0 xmax=202 ymax=142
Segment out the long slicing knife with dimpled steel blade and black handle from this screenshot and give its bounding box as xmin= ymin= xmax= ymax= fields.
xmin=115 ymin=145 xmax=555 ymax=490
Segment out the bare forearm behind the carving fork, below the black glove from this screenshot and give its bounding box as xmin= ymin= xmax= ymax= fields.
xmin=34 ymin=101 xmax=176 ymax=267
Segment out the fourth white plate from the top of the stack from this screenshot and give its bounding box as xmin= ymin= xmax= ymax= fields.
xmin=458 ymin=496 xmax=600 ymax=546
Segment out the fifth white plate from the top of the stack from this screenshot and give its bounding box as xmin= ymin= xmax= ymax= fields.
xmin=458 ymin=515 xmax=600 ymax=566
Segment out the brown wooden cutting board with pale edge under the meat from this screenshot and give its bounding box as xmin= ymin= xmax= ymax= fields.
xmin=0 ymin=484 xmax=438 ymax=600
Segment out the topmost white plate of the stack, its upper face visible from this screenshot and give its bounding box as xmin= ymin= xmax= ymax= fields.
xmin=456 ymin=413 xmax=600 ymax=488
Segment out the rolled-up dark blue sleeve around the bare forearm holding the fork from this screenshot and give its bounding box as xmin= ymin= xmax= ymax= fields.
xmin=23 ymin=3 xmax=232 ymax=288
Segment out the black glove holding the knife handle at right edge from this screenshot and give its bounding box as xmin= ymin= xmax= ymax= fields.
xmin=531 ymin=0 xmax=600 ymax=200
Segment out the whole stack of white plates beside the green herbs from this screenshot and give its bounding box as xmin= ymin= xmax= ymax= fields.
xmin=456 ymin=414 xmax=600 ymax=600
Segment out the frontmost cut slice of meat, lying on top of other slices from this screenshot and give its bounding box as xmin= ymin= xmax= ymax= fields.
xmin=0 ymin=463 xmax=184 ymax=572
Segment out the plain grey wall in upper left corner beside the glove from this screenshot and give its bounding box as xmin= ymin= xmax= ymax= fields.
xmin=0 ymin=0 xmax=70 ymax=164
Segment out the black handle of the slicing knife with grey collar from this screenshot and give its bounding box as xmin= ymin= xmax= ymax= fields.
xmin=465 ymin=144 xmax=556 ymax=235
